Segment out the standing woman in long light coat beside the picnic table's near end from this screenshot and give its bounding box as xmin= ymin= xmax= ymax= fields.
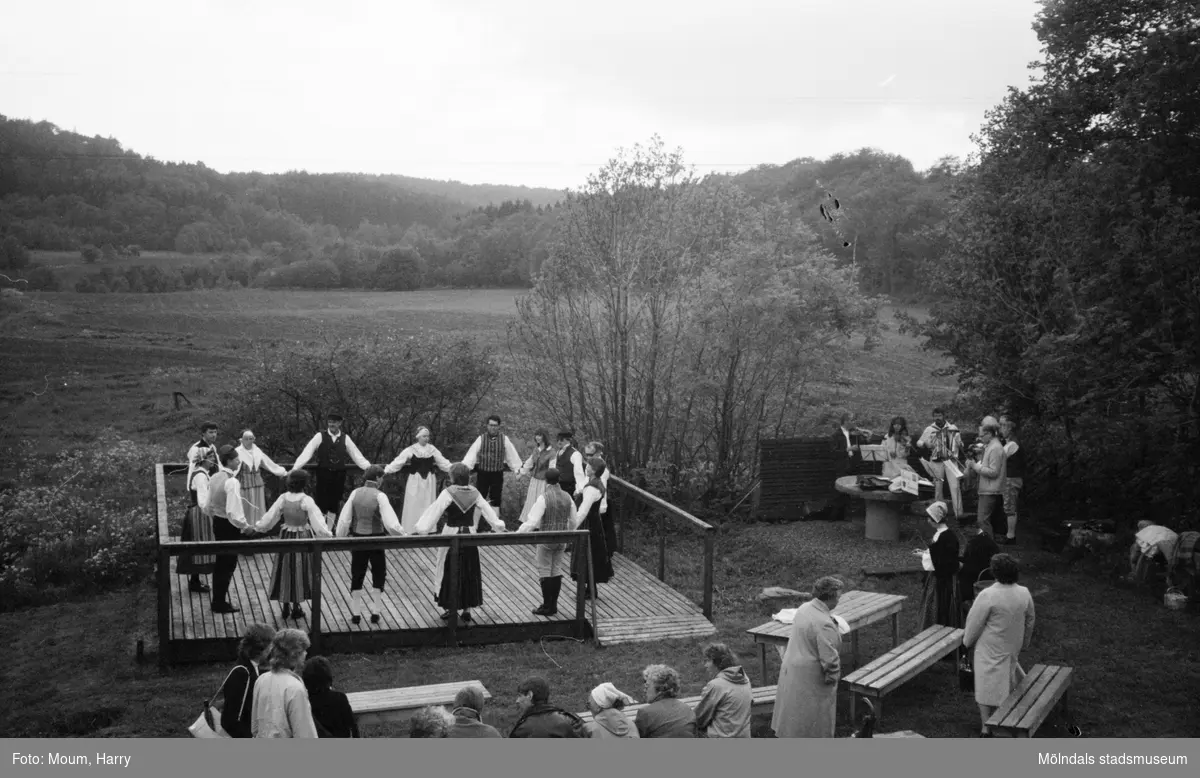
xmin=770 ymin=576 xmax=846 ymax=737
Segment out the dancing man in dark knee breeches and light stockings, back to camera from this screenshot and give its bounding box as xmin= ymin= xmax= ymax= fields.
xmin=335 ymin=465 xmax=408 ymax=624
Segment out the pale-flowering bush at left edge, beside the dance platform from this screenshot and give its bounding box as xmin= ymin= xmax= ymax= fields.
xmin=0 ymin=430 xmax=167 ymax=611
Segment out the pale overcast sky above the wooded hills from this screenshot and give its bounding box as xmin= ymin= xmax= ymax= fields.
xmin=0 ymin=0 xmax=1039 ymax=188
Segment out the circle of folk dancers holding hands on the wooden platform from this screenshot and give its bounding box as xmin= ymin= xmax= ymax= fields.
xmin=175 ymin=413 xmax=617 ymax=624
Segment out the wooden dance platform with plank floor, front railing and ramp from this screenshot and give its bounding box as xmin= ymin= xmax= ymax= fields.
xmin=150 ymin=466 xmax=716 ymax=664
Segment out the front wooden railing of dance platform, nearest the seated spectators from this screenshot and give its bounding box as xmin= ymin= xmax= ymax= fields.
xmin=155 ymin=463 xmax=600 ymax=663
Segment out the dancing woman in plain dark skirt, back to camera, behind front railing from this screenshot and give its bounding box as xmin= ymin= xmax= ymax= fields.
xmin=416 ymin=462 xmax=508 ymax=623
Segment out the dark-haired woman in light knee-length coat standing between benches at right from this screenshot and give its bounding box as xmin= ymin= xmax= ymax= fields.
xmin=962 ymin=553 xmax=1034 ymax=737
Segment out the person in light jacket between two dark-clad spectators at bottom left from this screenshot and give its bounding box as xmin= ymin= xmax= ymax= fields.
xmin=251 ymin=629 xmax=317 ymax=737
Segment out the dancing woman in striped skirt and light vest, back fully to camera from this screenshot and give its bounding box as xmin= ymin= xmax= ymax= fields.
xmin=254 ymin=471 xmax=334 ymax=620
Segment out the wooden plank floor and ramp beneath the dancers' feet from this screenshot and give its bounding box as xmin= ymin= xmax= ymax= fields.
xmin=170 ymin=545 xmax=716 ymax=645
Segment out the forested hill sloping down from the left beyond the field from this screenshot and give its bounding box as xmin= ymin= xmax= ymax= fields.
xmin=0 ymin=115 xmax=563 ymax=251
